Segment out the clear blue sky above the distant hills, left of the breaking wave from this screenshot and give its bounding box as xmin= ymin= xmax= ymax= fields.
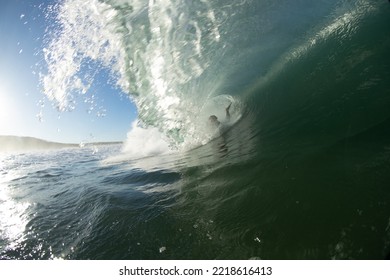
xmin=0 ymin=0 xmax=137 ymax=143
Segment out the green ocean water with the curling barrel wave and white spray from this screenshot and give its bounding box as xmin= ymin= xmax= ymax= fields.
xmin=0 ymin=0 xmax=390 ymax=259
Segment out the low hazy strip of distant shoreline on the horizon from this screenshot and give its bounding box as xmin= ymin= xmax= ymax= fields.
xmin=0 ymin=135 xmax=123 ymax=152
